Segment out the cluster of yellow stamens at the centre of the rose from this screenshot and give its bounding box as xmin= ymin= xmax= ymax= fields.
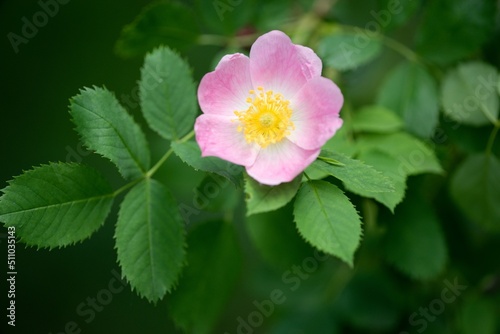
xmin=234 ymin=87 xmax=294 ymax=148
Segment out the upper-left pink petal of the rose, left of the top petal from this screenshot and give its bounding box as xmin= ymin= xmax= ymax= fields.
xmin=198 ymin=53 xmax=253 ymax=117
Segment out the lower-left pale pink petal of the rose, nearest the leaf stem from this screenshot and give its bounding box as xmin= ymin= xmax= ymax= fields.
xmin=194 ymin=114 xmax=260 ymax=166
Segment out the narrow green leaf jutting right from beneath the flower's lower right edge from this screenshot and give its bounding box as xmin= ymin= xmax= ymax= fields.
xmin=313 ymin=151 xmax=394 ymax=195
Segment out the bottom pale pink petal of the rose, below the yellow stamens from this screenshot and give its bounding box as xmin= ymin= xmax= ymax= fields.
xmin=246 ymin=139 xmax=320 ymax=186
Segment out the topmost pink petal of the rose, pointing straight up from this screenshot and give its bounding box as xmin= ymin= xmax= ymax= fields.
xmin=250 ymin=30 xmax=321 ymax=99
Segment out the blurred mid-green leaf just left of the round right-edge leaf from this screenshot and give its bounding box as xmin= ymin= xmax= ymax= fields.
xmin=377 ymin=62 xmax=439 ymax=138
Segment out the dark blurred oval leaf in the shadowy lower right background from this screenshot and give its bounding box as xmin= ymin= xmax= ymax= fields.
xmin=383 ymin=194 xmax=447 ymax=280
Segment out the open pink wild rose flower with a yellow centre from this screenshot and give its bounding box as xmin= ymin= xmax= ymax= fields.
xmin=194 ymin=31 xmax=344 ymax=185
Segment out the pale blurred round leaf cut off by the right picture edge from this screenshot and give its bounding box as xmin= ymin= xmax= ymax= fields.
xmin=441 ymin=61 xmax=499 ymax=126
